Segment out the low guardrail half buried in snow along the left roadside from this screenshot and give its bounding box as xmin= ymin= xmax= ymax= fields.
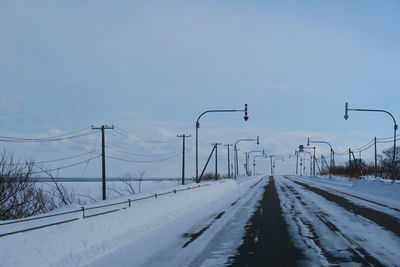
xmin=0 ymin=184 xmax=210 ymax=237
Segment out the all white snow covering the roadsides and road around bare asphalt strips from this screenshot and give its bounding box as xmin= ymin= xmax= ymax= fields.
xmin=0 ymin=176 xmax=400 ymax=267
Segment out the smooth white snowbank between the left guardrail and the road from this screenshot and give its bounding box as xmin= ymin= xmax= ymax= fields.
xmin=0 ymin=180 xmax=238 ymax=266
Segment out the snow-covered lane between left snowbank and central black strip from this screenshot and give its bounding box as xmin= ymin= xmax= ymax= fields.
xmin=89 ymin=177 xmax=268 ymax=266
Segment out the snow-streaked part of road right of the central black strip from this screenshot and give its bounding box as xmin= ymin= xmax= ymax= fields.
xmin=275 ymin=177 xmax=400 ymax=266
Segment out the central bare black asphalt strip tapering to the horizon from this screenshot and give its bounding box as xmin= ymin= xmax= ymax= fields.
xmin=228 ymin=177 xmax=304 ymax=266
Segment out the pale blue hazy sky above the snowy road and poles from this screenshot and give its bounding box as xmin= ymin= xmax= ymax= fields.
xmin=0 ymin=0 xmax=400 ymax=177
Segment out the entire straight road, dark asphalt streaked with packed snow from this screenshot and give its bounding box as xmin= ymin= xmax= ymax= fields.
xmin=86 ymin=176 xmax=400 ymax=267
